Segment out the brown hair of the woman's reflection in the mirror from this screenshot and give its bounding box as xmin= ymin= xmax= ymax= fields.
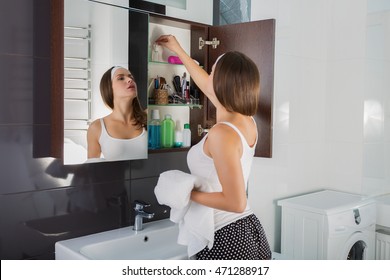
xmin=100 ymin=66 xmax=147 ymax=129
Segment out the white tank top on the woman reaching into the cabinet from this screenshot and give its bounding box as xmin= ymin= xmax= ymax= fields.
xmin=187 ymin=119 xmax=257 ymax=230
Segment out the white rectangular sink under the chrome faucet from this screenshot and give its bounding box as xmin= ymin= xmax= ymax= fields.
xmin=55 ymin=219 xmax=188 ymax=260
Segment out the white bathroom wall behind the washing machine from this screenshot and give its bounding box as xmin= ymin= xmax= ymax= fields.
xmin=249 ymin=0 xmax=390 ymax=254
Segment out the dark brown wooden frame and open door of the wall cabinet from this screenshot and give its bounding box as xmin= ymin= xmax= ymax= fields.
xmin=48 ymin=0 xmax=275 ymax=158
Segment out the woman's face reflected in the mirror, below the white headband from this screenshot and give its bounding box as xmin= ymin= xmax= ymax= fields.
xmin=112 ymin=68 xmax=137 ymax=102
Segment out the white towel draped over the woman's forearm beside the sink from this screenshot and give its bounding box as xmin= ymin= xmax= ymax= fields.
xmin=154 ymin=170 xmax=214 ymax=257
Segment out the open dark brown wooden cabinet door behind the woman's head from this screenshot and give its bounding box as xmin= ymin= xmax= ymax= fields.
xmin=206 ymin=19 xmax=275 ymax=157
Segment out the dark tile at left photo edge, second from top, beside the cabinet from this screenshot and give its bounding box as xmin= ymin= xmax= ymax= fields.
xmin=0 ymin=55 xmax=33 ymax=125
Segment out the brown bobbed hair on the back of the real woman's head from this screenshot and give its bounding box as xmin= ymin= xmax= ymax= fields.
xmin=213 ymin=51 xmax=260 ymax=116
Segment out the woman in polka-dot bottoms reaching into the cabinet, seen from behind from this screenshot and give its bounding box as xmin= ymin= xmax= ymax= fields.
xmin=156 ymin=35 xmax=271 ymax=259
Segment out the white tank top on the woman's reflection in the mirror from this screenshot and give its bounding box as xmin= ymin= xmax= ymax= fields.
xmin=99 ymin=118 xmax=148 ymax=160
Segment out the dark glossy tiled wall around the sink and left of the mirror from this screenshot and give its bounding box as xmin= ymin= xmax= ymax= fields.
xmin=0 ymin=0 xmax=188 ymax=259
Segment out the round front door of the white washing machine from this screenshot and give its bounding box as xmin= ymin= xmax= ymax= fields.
xmin=340 ymin=232 xmax=375 ymax=260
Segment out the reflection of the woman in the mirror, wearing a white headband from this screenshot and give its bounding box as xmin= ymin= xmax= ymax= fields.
xmin=87 ymin=66 xmax=148 ymax=160
